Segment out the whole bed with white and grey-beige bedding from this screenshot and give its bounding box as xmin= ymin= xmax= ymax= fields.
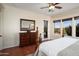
xmin=34 ymin=36 xmax=79 ymax=56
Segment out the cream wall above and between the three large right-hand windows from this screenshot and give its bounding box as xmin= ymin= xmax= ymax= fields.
xmin=50 ymin=7 xmax=79 ymax=38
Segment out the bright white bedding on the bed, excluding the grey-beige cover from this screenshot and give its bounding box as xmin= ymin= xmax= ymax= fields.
xmin=35 ymin=36 xmax=79 ymax=56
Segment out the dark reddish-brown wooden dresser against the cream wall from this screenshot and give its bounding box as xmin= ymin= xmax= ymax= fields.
xmin=19 ymin=28 xmax=38 ymax=47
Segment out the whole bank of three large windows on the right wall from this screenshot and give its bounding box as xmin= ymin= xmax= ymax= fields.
xmin=54 ymin=16 xmax=79 ymax=37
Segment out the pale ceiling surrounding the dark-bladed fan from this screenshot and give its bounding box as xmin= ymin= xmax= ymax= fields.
xmin=7 ymin=3 xmax=79 ymax=16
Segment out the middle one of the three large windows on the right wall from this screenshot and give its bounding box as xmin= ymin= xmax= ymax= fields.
xmin=62 ymin=18 xmax=72 ymax=36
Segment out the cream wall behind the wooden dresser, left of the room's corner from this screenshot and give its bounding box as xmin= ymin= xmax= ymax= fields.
xmin=3 ymin=5 xmax=50 ymax=48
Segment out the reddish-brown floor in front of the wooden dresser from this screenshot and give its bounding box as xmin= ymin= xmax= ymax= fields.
xmin=0 ymin=45 xmax=35 ymax=56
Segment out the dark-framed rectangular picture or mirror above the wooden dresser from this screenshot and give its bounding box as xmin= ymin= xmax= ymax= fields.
xmin=20 ymin=19 xmax=35 ymax=31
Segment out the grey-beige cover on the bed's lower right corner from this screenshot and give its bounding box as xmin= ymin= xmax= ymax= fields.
xmin=58 ymin=41 xmax=79 ymax=56
